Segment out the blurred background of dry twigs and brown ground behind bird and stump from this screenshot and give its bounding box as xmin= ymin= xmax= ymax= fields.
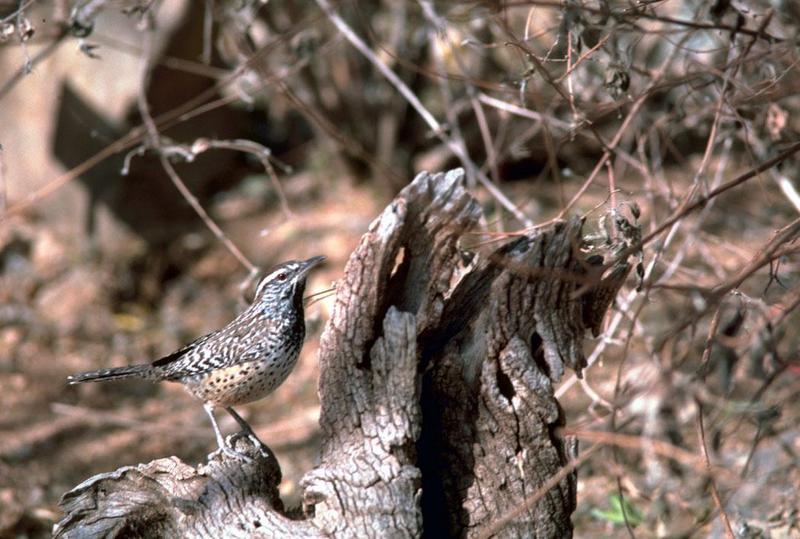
xmin=0 ymin=0 xmax=800 ymax=537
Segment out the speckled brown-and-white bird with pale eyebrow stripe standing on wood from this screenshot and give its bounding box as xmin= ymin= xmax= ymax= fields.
xmin=67 ymin=256 xmax=325 ymax=457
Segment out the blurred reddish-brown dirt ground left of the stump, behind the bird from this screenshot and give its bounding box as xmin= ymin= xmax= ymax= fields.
xmin=0 ymin=170 xmax=378 ymax=537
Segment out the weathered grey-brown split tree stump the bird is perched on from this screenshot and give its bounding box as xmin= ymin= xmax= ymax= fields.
xmin=55 ymin=169 xmax=627 ymax=537
